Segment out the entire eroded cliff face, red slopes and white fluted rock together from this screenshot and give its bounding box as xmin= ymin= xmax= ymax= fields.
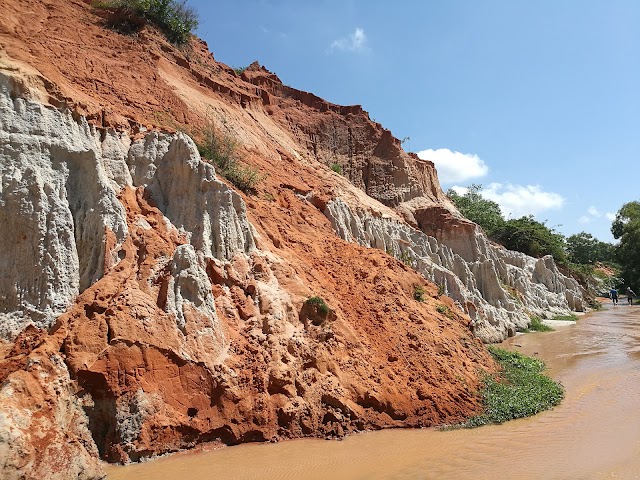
xmin=0 ymin=0 xmax=581 ymax=479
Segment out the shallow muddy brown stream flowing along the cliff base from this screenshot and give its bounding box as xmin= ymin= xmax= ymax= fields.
xmin=107 ymin=304 xmax=640 ymax=480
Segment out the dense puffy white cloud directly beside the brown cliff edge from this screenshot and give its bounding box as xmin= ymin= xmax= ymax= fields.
xmin=418 ymin=148 xmax=489 ymax=184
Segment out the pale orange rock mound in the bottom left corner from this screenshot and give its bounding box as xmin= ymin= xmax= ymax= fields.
xmin=0 ymin=327 xmax=102 ymax=480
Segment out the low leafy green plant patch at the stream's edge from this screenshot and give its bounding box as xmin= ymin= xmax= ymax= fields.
xmin=461 ymin=346 xmax=564 ymax=428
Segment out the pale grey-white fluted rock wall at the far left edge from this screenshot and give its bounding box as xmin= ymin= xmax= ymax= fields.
xmin=0 ymin=84 xmax=127 ymax=337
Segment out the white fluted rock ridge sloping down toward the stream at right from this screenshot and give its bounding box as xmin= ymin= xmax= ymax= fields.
xmin=324 ymin=198 xmax=583 ymax=342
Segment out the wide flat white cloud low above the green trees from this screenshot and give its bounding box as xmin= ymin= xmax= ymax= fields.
xmin=482 ymin=183 xmax=564 ymax=218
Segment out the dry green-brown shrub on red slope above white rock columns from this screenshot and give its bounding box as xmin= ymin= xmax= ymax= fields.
xmin=198 ymin=124 xmax=266 ymax=193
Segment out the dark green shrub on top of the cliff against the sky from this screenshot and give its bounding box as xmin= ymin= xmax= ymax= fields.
xmin=94 ymin=0 xmax=198 ymax=45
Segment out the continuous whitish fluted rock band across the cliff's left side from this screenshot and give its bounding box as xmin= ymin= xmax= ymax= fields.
xmin=0 ymin=81 xmax=255 ymax=338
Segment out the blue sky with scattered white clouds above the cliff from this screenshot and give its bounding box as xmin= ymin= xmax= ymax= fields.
xmin=189 ymin=0 xmax=640 ymax=241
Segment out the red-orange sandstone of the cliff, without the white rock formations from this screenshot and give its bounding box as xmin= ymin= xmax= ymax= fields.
xmin=0 ymin=0 xmax=524 ymax=478
